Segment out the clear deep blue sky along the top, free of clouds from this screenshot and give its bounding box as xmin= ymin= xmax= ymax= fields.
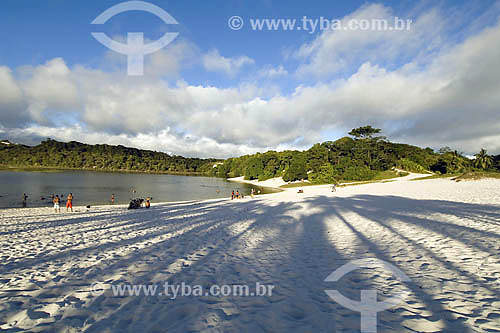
xmin=0 ymin=0 xmax=390 ymax=66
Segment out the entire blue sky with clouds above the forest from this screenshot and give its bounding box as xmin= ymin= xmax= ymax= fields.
xmin=0 ymin=0 xmax=500 ymax=158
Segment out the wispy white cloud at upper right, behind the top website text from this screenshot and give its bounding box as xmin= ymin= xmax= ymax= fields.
xmin=294 ymin=4 xmax=452 ymax=78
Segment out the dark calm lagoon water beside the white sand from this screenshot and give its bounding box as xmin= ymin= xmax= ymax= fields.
xmin=0 ymin=171 xmax=258 ymax=208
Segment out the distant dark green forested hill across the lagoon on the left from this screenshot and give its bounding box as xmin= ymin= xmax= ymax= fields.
xmin=0 ymin=139 xmax=220 ymax=174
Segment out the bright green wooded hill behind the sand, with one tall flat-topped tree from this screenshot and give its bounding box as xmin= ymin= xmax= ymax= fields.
xmin=213 ymin=126 xmax=492 ymax=184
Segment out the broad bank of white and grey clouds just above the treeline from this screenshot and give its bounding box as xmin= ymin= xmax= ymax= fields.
xmin=0 ymin=6 xmax=500 ymax=157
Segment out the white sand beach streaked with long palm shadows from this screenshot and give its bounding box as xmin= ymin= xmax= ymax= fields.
xmin=0 ymin=177 xmax=500 ymax=332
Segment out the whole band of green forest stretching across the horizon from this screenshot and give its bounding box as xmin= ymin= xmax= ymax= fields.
xmin=0 ymin=126 xmax=500 ymax=184
